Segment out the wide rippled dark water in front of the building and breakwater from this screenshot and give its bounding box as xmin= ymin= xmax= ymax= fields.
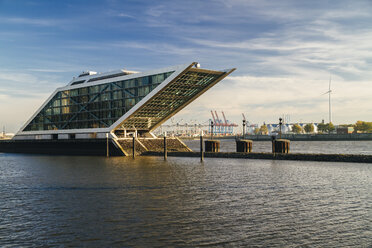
xmin=0 ymin=154 xmax=372 ymax=247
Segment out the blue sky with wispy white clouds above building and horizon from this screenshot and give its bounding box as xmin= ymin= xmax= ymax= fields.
xmin=0 ymin=0 xmax=372 ymax=132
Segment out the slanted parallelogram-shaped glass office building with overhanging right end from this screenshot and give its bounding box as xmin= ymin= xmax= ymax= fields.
xmin=15 ymin=62 xmax=234 ymax=139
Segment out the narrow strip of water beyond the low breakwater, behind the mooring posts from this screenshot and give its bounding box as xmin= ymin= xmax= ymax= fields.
xmin=183 ymin=139 xmax=372 ymax=155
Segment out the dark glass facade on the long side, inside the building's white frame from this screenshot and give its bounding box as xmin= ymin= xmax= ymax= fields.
xmin=23 ymin=72 xmax=173 ymax=131
